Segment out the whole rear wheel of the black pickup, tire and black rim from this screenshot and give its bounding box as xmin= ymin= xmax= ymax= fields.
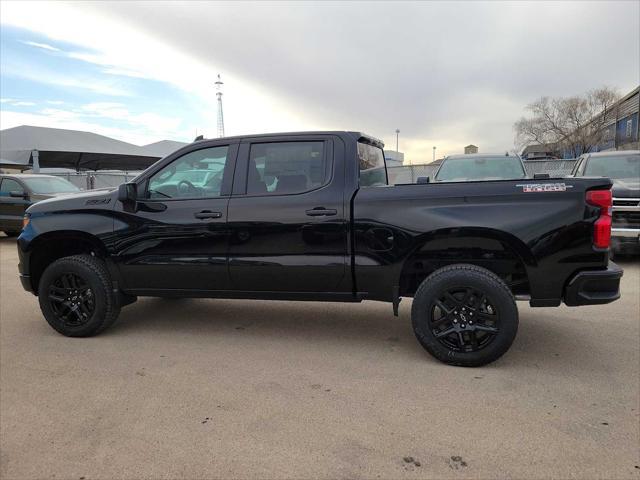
xmin=411 ymin=264 xmax=518 ymax=367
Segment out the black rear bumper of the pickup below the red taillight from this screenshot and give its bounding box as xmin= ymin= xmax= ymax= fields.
xmin=564 ymin=262 xmax=623 ymax=307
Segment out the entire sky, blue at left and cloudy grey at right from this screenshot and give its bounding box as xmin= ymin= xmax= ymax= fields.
xmin=0 ymin=0 xmax=640 ymax=163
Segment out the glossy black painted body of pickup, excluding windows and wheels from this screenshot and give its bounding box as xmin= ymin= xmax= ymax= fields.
xmin=18 ymin=132 xmax=621 ymax=306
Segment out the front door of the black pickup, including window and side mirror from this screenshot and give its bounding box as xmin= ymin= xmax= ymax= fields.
xmin=114 ymin=144 xmax=237 ymax=294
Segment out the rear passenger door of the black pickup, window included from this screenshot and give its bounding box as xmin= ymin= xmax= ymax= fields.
xmin=229 ymin=136 xmax=349 ymax=293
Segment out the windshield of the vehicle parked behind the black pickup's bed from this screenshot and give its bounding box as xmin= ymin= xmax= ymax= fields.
xmin=435 ymin=155 xmax=526 ymax=182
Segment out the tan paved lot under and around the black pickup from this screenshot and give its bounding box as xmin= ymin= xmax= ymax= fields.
xmin=0 ymin=237 xmax=640 ymax=480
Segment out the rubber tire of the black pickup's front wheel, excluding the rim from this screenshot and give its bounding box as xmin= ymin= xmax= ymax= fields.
xmin=38 ymin=258 xmax=109 ymax=337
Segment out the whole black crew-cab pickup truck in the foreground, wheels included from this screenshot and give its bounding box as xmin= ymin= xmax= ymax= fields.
xmin=18 ymin=132 xmax=622 ymax=366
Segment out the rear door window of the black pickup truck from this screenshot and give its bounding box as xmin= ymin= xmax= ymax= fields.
xmin=247 ymin=142 xmax=330 ymax=195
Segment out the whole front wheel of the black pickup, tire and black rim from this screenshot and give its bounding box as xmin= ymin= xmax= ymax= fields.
xmin=38 ymin=255 xmax=120 ymax=337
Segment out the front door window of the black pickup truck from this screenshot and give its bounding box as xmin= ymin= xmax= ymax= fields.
xmin=147 ymin=146 xmax=229 ymax=200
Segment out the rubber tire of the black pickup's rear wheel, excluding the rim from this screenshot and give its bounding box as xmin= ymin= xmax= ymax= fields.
xmin=411 ymin=269 xmax=518 ymax=367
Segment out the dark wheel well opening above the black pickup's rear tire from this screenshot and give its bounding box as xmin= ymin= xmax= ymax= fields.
xmin=397 ymin=227 xmax=536 ymax=297
